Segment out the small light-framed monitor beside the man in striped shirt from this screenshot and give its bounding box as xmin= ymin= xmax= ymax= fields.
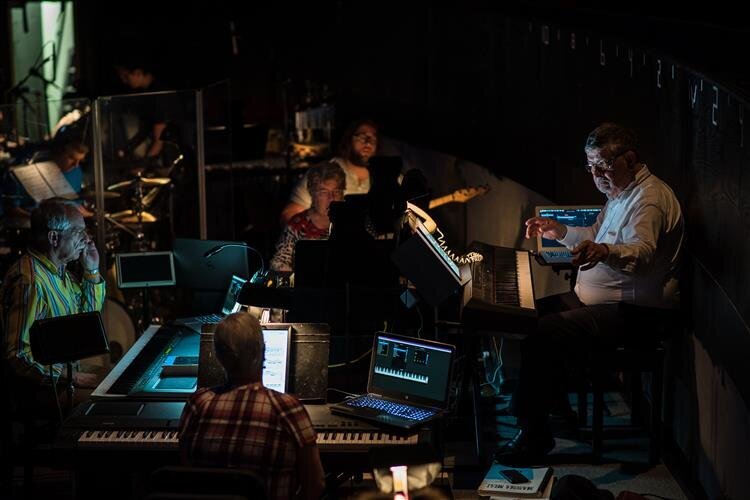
xmin=115 ymin=252 xmax=175 ymax=288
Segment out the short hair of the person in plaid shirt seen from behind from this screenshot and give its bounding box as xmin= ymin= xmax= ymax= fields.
xmin=214 ymin=312 xmax=266 ymax=377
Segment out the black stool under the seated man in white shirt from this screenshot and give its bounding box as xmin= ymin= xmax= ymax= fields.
xmin=578 ymin=304 xmax=682 ymax=465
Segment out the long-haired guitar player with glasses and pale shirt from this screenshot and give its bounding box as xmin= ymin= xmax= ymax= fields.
xmin=281 ymin=120 xmax=378 ymax=224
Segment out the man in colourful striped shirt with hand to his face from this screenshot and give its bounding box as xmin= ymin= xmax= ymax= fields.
xmin=0 ymin=198 xmax=105 ymax=387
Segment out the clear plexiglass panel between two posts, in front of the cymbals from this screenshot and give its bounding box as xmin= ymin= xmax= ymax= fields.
xmin=94 ymin=90 xmax=202 ymax=270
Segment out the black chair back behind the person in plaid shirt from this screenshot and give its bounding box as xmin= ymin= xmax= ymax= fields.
xmin=147 ymin=466 xmax=267 ymax=500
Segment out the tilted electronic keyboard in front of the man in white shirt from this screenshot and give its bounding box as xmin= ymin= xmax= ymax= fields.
xmin=461 ymin=242 xmax=538 ymax=335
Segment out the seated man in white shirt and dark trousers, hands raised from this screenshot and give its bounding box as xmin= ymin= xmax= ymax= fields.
xmin=497 ymin=123 xmax=684 ymax=462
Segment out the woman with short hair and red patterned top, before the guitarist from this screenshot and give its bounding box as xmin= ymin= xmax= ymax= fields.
xmin=271 ymin=162 xmax=347 ymax=272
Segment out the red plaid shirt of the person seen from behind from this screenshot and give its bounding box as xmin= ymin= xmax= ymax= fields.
xmin=180 ymin=382 xmax=316 ymax=499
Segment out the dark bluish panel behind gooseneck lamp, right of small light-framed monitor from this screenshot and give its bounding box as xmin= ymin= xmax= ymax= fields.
xmin=172 ymin=238 xmax=248 ymax=293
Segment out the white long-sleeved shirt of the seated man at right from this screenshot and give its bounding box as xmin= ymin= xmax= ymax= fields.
xmin=560 ymin=165 xmax=684 ymax=308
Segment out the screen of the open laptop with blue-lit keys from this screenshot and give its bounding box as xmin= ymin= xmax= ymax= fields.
xmin=368 ymin=333 xmax=455 ymax=408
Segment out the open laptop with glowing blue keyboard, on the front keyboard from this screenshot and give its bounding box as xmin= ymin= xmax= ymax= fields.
xmin=330 ymin=332 xmax=456 ymax=429
